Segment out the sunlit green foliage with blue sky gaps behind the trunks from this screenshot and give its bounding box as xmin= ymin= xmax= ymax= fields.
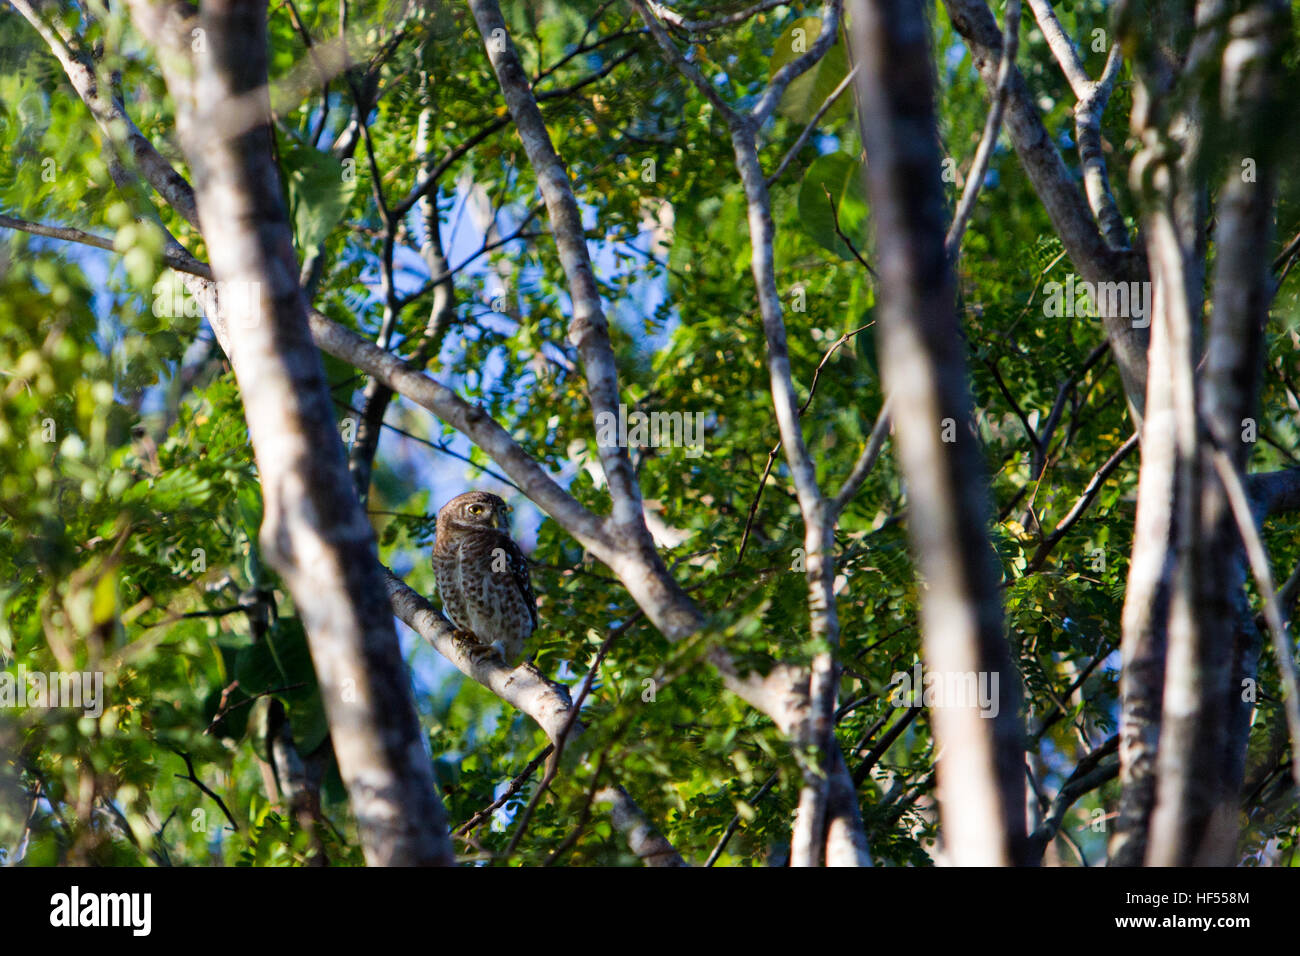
xmin=0 ymin=0 xmax=1300 ymax=865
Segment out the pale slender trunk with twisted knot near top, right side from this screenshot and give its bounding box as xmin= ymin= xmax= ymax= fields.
xmin=1110 ymin=0 xmax=1208 ymax=866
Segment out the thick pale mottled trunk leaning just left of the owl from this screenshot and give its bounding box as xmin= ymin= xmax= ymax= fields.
xmin=124 ymin=0 xmax=451 ymax=865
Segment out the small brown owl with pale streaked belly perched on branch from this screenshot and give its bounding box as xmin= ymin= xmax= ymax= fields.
xmin=433 ymin=492 xmax=537 ymax=665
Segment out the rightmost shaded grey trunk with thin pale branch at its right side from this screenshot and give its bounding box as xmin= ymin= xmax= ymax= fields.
xmin=1148 ymin=3 xmax=1295 ymax=865
